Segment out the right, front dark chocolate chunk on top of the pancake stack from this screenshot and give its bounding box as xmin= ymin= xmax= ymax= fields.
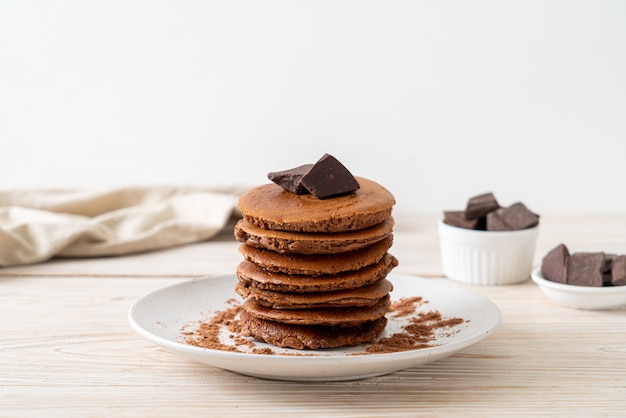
xmin=300 ymin=154 xmax=360 ymax=199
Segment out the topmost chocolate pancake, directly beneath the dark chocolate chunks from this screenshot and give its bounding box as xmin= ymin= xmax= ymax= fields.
xmin=239 ymin=177 xmax=396 ymax=232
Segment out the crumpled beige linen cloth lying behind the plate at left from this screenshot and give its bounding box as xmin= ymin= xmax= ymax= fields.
xmin=0 ymin=186 xmax=244 ymax=267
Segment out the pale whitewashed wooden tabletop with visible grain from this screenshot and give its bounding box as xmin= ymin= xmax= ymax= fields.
xmin=0 ymin=215 xmax=626 ymax=417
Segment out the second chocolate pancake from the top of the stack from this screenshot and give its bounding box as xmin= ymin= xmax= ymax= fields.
xmin=234 ymin=217 xmax=394 ymax=254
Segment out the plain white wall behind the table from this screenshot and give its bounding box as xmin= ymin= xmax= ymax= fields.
xmin=0 ymin=0 xmax=626 ymax=213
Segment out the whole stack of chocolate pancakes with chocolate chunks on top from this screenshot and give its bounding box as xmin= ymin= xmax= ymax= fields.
xmin=234 ymin=154 xmax=398 ymax=349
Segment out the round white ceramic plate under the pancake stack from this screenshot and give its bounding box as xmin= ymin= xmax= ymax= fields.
xmin=128 ymin=274 xmax=501 ymax=381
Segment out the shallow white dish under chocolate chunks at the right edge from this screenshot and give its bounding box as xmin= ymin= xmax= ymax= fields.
xmin=531 ymin=268 xmax=626 ymax=310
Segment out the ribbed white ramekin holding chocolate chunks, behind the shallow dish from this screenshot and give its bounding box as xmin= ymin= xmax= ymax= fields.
xmin=439 ymin=221 xmax=539 ymax=285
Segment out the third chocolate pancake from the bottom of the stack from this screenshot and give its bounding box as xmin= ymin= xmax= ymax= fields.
xmin=235 ymin=280 xmax=393 ymax=309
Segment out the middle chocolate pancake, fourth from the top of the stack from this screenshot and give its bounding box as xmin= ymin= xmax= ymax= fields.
xmin=237 ymin=253 xmax=398 ymax=293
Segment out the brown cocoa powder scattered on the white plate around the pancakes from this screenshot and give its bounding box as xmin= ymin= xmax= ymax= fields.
xmin=182 ymin=296 xmax=465 ymax=355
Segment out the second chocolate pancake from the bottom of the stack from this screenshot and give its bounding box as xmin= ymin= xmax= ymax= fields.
xmin=243 ymin=295 xmax=391 ymax=327
